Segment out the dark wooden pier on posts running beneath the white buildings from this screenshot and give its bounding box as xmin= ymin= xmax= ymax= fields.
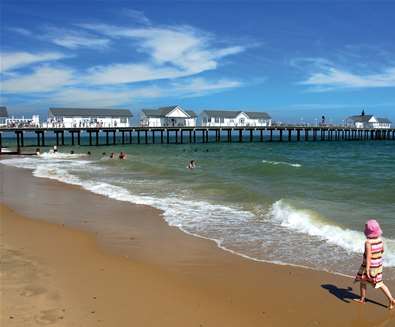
xmin=0 ymin=126 xmax=395 ymax=149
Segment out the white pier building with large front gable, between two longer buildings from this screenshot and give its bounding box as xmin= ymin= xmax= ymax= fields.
xmin=140 ymin=105 xmax=196 ymax=127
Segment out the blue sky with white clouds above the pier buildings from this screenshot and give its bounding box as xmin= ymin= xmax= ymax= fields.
xmin=0 ymin=0 xmax=395 ymax=123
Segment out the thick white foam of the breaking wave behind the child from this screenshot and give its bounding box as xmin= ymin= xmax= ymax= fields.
xmin=270 ymin=200 xmax=395 ymax=267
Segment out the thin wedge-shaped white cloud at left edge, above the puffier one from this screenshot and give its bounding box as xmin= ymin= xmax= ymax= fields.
xmin=0 ymin=52 xmax=66 ymax=73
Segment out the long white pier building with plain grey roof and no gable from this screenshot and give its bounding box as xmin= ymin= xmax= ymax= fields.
xmin=47 ymin=108 xmax=133 ymax=128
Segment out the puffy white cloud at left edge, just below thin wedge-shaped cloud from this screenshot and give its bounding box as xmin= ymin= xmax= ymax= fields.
xmin=0 ymin=66 xmax=73 ymax=94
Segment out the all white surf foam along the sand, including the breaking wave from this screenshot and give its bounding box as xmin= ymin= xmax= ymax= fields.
xmin=0 ymin=154 xmax=395 ymax=270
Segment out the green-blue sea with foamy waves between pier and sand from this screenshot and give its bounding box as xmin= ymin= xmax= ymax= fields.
xmin=0 ymin=141 xmax=395 ymax=279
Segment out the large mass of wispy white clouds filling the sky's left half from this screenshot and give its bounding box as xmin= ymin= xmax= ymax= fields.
xmin=1 ymin=10 xmax=248 ymax=106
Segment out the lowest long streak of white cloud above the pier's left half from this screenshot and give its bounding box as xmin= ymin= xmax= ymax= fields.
xmin=6 ymin=75 xmax=242 ymax=107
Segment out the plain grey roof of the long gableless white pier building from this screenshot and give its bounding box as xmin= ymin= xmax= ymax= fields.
xmin=48 ymin=108 xmax=133 ymax=117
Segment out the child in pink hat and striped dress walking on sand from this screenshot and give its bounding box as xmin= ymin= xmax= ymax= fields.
xmin=355 ymin=219 xmax=395 ymax=309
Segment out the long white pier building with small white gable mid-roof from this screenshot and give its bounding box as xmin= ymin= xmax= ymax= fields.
xmin=201 ymin=110 xmax=272 ymax=127
